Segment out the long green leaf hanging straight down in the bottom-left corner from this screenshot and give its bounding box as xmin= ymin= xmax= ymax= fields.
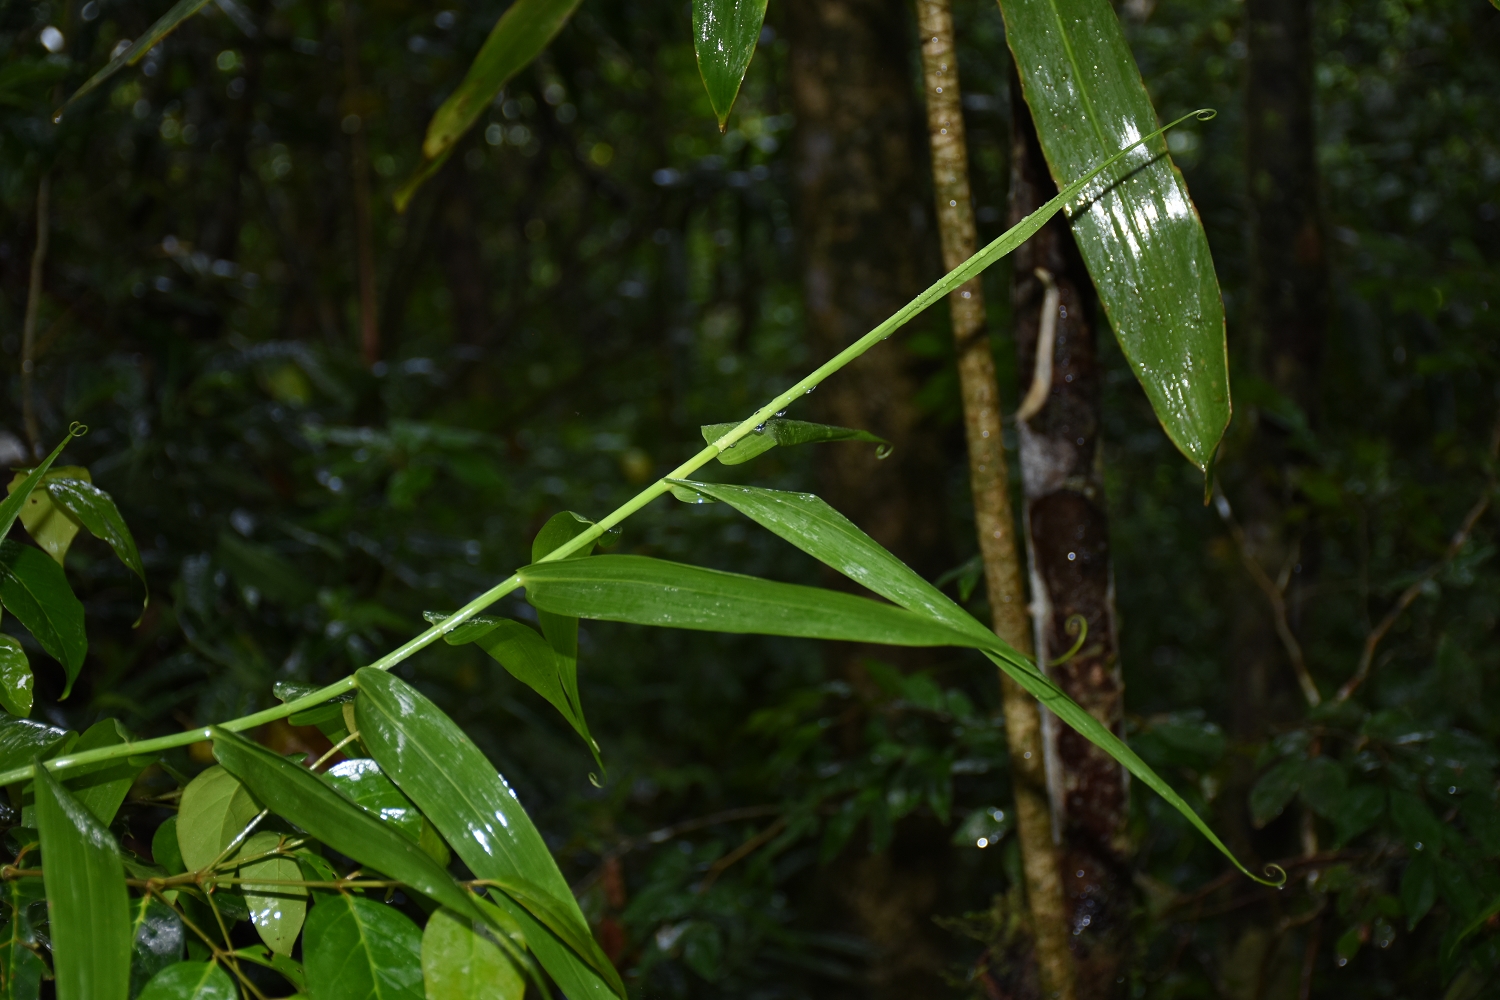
xmin=36 ymin=760 xmax=131 ymax=1000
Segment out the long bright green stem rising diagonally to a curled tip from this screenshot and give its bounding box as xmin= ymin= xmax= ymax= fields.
xmin=0 ymin=109 xmax=1215 ymax=786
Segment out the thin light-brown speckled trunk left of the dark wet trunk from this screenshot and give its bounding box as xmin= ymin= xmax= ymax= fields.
xmin=917 ymin=7 xmax=1074 ymax=1000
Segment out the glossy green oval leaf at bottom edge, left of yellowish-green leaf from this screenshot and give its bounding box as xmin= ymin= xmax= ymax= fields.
xmin=303 ymin=892 xmax=425 ymax=1000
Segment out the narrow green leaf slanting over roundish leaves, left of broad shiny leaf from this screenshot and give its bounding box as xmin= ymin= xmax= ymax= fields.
xmin=210 ymin=726 xmax=480 ymax=929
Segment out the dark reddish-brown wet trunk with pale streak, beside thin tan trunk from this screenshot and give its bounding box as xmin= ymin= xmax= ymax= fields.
xmin=1010 ymin=76 xmax=1131 ymax=999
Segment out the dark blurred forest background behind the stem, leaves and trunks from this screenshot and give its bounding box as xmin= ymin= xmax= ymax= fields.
xmin=0 ymin=0 xmax=1500 ymax=1000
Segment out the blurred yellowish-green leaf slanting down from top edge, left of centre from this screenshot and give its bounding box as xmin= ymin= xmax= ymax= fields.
xmin=396 ymin=0 xmax=579 ymax=211
